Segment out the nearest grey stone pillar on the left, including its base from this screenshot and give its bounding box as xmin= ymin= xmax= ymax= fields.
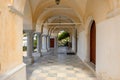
xmin=24 ymin=30 xmax=34 ymax=64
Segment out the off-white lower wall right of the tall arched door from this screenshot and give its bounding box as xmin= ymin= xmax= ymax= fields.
xmin=96 ymin=16 xmax=120 ymax=80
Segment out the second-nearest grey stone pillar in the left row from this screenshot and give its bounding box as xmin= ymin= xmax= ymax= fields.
xmin=36 ymin=32 xmax=42 ymax=56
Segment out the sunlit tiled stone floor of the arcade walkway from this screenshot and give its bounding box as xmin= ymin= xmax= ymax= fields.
xmin=27 ymin=48 xmax=97 ymax=80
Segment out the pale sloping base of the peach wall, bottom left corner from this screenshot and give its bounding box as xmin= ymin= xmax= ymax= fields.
xmin=0 ymin=63 xmax=26 ymax=80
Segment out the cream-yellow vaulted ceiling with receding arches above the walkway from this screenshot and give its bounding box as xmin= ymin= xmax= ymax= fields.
xmin=24 ymin=0 xmax=109 ymax=33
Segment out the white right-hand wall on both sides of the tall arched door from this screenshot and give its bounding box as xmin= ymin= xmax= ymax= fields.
xmin=77 ymin=16 xmax=120 ymax=80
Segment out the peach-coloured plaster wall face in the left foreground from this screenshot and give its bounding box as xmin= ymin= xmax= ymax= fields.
xmin=0 ymin=0 xmax=23 ymax=74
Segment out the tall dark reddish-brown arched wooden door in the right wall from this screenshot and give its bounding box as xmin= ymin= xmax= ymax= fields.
xmin=90 ymin=21 xmax=96 ymax=64
